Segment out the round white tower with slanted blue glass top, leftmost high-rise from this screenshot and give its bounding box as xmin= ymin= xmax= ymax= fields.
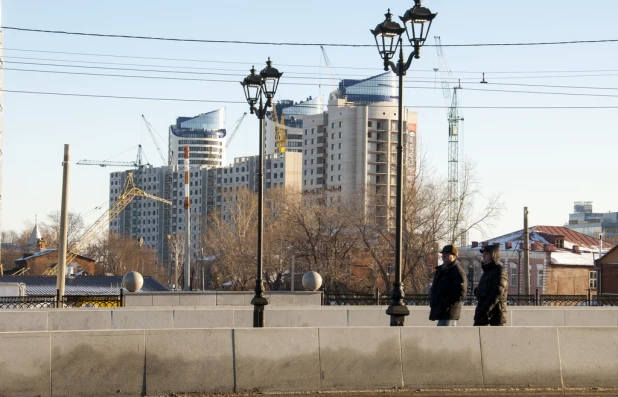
xmin=169 ymin=108 xmax=226 ymax=167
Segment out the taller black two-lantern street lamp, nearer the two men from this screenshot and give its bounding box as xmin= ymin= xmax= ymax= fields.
xmin=371 ymin=0 xmax=437 ymax=326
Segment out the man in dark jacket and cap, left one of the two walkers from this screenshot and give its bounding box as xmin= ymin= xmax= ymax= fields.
xmin=429 ymin=245 xmax=467 ymax=327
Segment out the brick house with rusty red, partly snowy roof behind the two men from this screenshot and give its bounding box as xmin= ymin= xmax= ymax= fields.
xmin=459 ymin=226 xmax=614 ymax=295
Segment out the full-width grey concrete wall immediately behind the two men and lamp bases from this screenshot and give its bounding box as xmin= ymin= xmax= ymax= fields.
xmin=0 ymin=306 xmax=618 ymax=332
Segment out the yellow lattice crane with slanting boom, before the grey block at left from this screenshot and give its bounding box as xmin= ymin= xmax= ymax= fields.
xmin=43 ymin=172 xmax=172 ymax=276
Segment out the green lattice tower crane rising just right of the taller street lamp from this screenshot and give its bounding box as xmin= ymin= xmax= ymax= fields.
xmin=434 ymin=36 xmax=463 ymax=243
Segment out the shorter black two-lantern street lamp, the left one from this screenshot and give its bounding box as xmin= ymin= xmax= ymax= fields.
xmin=240 ymin=58 xmax=283 ymax=328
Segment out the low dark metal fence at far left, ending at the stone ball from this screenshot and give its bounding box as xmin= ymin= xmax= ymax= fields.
xmin=0 ymin=290 xmax=124 ymax=310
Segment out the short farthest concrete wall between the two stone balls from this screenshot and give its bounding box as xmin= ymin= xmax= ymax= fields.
xmin=125 ymin=291 xmax=322 ymax=307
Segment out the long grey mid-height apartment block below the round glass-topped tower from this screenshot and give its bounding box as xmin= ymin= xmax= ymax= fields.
xmin=110 ymin=153 xmax=302 ymax=261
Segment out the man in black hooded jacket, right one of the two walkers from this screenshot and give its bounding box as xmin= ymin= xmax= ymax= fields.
xmin=474 ymin=245 xmax=508 ymax=326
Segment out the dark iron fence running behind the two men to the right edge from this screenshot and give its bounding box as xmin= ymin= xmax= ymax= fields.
xmin=324 ymin=290 xmax=618 ymax=306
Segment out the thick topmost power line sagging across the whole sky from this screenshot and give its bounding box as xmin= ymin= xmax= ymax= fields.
xmin=0 ymin=26 xmax=618 ymax=48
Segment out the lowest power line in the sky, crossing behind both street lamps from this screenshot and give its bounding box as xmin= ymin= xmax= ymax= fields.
xmin=0 ymin=89 xmax=618 ymax=110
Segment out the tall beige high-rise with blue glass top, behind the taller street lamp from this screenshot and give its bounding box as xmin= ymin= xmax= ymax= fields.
xmin=302 ymin=73 xmax=418 ymax=226
